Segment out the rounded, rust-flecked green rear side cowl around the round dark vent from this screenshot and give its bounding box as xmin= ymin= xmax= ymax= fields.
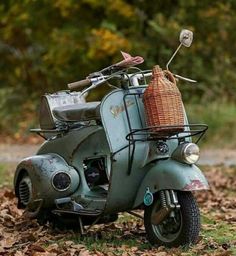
xmin=14 ymin=154 xmax=80 ymax=207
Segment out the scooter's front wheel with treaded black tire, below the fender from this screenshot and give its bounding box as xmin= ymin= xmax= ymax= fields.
xmin=144 ymin=191 xmax=201 ymax=247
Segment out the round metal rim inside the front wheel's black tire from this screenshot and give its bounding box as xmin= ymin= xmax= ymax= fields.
xmin=152 ymin=203 xmax=183 ymax=243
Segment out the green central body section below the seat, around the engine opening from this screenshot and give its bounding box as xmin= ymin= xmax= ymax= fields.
xmin=37 ymin=126 xmax=111 ymax=209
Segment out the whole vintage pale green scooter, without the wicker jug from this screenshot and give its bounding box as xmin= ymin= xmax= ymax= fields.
xmin=14 ymin=30 xmax=208 ymax=247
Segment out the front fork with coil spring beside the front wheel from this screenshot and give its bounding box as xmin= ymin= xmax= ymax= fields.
xmin=151 ymin=189 xmax=180 ymax=225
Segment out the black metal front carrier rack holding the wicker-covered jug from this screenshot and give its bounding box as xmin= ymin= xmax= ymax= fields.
xmin=123 ymin=88 xmax=208 ymax=175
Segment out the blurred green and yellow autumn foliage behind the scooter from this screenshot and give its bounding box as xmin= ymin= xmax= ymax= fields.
xmin=0 ymin=0 xmax=236 ymax=144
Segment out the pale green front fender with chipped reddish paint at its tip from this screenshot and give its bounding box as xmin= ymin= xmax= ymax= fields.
xmin=133 ymin=159 xmax=209 ymax=208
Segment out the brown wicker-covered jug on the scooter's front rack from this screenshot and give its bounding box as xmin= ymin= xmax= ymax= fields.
xmin=143 ymin=65 xmax=184 ymax=135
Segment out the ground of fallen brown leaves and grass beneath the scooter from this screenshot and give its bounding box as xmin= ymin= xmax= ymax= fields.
xmin=0 ymin=166 xmax=236 ymax=256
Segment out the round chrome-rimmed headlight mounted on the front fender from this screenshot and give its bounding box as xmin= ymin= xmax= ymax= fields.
xmin=171 ymin=143 xmax=200 ymax=164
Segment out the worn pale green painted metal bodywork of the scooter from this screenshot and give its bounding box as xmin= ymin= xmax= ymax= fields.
xmin=15 ymin=86 xmax=208 ymax=214
